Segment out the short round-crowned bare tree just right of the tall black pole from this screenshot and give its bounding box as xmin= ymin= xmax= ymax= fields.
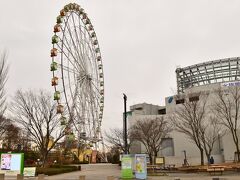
xmin=130 ymin=116 xmax=172 ymax=163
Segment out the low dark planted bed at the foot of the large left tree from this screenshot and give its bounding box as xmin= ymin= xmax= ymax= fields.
xmin=37 ymin=165 xmax=78 ymax=176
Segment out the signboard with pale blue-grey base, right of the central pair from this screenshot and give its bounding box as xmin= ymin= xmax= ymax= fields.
xmin=135 ymin=154 xmax=147 ymax=179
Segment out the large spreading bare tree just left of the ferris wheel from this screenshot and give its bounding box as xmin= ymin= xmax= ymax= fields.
xmin=11 ymin=90 xmax=64 ymax=165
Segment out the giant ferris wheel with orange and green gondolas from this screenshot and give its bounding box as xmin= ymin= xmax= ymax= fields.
xmin=51 ymin=3 xmax=104 ymax=146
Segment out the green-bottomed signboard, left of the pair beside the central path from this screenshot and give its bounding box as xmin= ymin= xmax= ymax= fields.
xmin=121 ymin=154 xmax=133 ymax=179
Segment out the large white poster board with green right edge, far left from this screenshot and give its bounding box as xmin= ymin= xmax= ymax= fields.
xmin=0 ymin=153 xmax=24 ymax=176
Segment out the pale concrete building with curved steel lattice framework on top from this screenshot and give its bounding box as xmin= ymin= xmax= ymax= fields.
xmin=128 ymin=58 xmax=240 ymax=166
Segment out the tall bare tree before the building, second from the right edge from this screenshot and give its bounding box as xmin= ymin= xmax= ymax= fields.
xmin=170 ymin=92 xmax=222 ymax=165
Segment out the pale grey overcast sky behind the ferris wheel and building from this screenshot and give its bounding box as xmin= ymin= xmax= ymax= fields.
xmin=0 ymin=0 xmax=240 ymax=129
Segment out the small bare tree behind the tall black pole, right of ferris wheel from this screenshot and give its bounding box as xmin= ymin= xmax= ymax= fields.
xmin=105 ymin=128 xmax=131 ymax=153
